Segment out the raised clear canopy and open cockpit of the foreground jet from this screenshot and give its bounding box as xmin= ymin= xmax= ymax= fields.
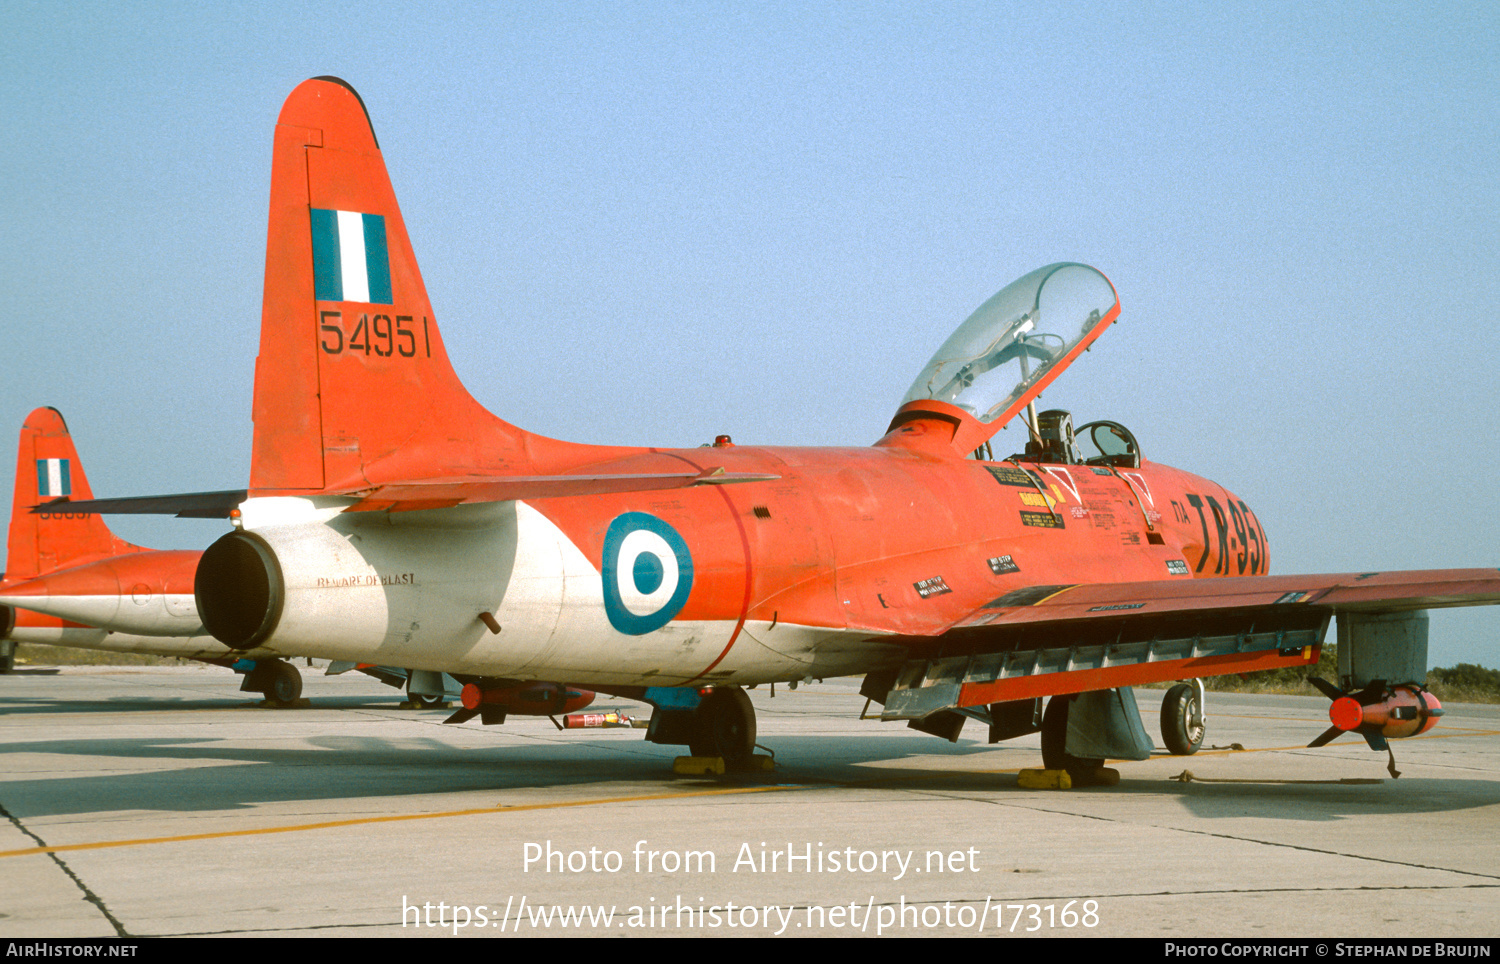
xmin=882 ymin=262 xmax=1140 ymax=465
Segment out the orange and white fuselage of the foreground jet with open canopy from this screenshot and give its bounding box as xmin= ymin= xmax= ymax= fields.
xmin=222 ymin=445 xmax=1268 ymax=687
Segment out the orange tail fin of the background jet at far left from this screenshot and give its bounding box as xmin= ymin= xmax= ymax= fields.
xmin=5 ymin=408 xmax=143 ymax=582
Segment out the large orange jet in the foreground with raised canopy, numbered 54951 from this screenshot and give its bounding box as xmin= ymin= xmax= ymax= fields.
xmin=52 ymin=78 xmax=1500 ymax=778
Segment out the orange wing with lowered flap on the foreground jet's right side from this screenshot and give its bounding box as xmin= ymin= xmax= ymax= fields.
xmin=867 ymin=568 xmax=1500 ymax=720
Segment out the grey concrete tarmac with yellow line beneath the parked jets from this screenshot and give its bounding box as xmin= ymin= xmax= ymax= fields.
xmin=0 ymin=667 xmax=1500 ymax=943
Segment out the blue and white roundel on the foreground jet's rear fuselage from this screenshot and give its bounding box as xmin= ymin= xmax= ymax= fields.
xmin=600 ymin=513 xmax=693 ymax=636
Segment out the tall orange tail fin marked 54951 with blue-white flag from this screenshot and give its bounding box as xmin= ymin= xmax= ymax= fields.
xmin=251 ymin=76 xmax=579 ymax=496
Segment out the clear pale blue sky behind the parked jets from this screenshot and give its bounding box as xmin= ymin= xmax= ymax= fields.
xmin=0 ymin=0 xmax=1500 ymax=666
